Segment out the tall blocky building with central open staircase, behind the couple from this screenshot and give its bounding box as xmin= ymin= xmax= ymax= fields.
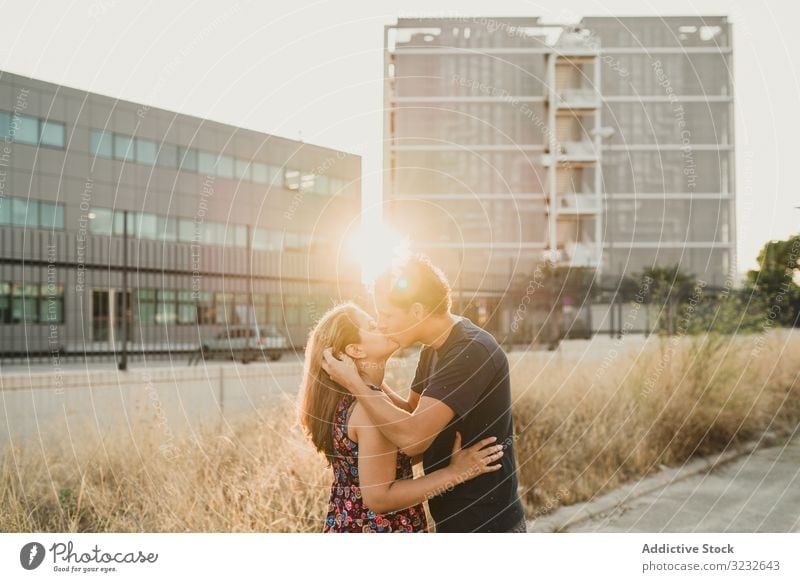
xmin=384 ymin=17 xmax=736 ymax=336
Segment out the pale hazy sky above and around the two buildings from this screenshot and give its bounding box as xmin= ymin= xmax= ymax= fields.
xmin=0 ymin=0 xmax=800 ymax=272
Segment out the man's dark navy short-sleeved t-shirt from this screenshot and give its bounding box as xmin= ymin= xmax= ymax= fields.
xmin=411 ymin=318 xmax=524 ymax=532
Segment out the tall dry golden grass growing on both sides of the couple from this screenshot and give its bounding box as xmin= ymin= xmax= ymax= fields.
xmin=0 ymin=332 xmax=800 ymax=532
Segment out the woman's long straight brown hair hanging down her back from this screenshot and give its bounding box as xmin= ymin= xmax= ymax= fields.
xmin=300 ymin=302 xmax=362 ymax=463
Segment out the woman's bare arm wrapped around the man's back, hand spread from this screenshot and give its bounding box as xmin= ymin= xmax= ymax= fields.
xmin=352 ymin=405 xmax=503 ymax=513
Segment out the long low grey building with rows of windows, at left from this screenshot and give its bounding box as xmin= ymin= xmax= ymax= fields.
xmin=0 ymin=72 xmax=361 ymax=357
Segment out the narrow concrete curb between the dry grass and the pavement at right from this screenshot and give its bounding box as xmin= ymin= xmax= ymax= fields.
xmin=527 ymin=438 xmax=769 ymax=533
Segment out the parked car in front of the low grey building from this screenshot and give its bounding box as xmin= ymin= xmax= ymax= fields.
xmin=189 ymin=325 xmax=290 ymax=364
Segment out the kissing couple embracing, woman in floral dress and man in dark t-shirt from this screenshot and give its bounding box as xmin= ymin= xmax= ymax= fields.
xmin=300 ymin=255 xmax=525 ymax=533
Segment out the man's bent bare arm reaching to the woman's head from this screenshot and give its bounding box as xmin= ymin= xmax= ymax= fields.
xmin=323 ymin=348 xmax=455 ymax=457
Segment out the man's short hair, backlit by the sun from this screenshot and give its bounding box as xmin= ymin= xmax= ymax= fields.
xmin=375 ymin=254 xmax=452 ymax=315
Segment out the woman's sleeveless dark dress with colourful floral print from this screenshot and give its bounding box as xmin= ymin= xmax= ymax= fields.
xmin=323 ymin=394 xmax=428 ymax=533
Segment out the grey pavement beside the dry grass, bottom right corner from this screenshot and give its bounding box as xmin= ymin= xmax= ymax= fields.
xmin=528 ymin=437 xmax=800 ymax=532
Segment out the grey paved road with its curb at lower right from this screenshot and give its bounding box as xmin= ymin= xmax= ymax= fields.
xmin=528 ymin=436 xmax=800 ymax=533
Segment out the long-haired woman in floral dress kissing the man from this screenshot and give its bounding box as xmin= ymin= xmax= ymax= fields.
xmin=300 ymin=303 xmax=503 ymax=532
